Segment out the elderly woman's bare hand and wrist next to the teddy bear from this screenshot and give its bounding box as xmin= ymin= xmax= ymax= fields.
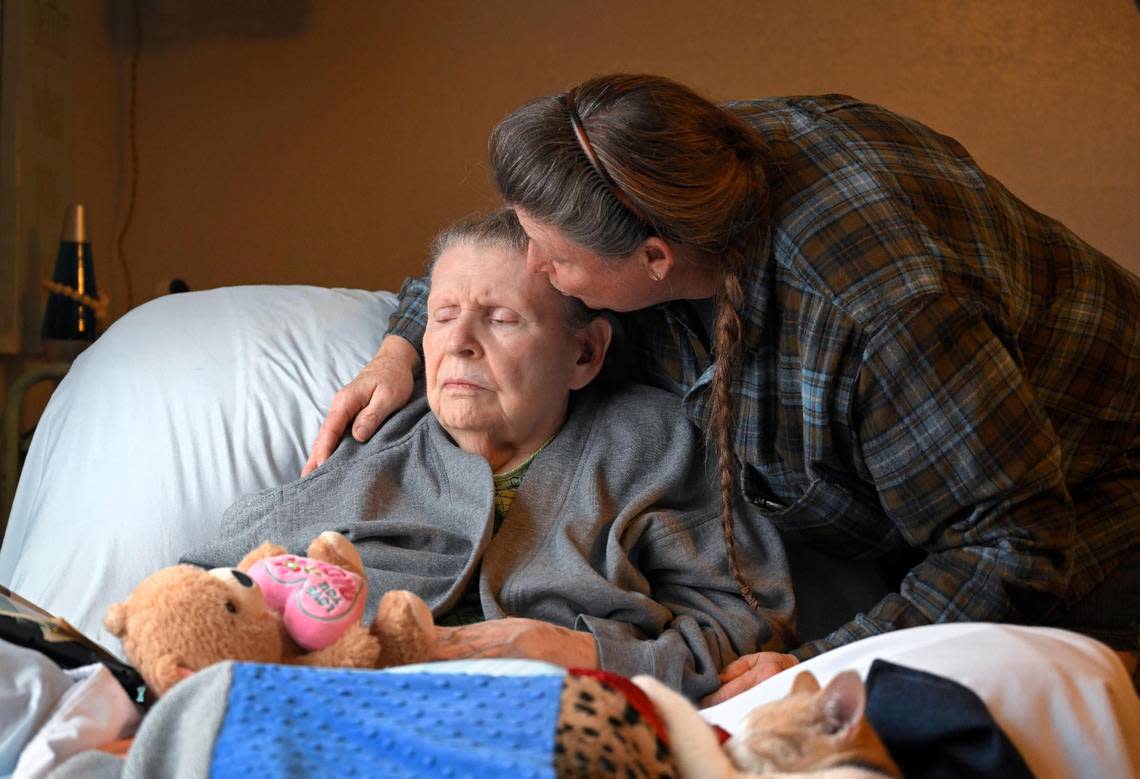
xmin=432 ymin=617 xmax=597 ymax=668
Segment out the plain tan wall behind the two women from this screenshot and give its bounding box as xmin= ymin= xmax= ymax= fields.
xmin=76 ymin=0 xmax=1140 ymax=313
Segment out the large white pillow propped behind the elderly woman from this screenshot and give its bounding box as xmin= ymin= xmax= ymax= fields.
xmin=0 ymin=286 xmax=396 ymax=652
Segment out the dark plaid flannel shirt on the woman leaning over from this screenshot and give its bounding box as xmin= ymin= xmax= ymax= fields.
xmin=390 ymin=96 xmax=1140 ymax=658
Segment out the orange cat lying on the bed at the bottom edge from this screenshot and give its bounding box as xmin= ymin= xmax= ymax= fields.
xmin=634 ymin=671 xmax=902 ymax=779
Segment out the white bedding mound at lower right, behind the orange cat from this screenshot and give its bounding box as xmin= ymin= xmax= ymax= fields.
xmin=701 ymin=623 xmax=1140 ymax=779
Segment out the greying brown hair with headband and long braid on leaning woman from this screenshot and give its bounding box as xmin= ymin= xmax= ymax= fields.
xmin=490 ymin=74 xmax=768 ymax=609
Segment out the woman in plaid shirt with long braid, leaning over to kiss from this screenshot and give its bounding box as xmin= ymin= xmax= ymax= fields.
xmin=307 ymin=75 xmax=1140 ymax=699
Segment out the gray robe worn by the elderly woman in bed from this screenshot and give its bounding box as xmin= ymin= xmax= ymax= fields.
xmin=185 ymin=387 xmax=793 ymax=697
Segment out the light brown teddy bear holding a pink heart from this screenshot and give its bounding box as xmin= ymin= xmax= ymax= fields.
xmin=104 ymin=533 xmax=433 ymax=696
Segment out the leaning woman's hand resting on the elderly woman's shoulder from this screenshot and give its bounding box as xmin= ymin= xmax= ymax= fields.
xmin=301 ymin=335 xmax=420 ymax=476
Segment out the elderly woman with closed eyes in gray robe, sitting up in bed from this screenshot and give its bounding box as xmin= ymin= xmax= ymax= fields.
xmin=186 ymin=211 xmax=793 ymax=697
